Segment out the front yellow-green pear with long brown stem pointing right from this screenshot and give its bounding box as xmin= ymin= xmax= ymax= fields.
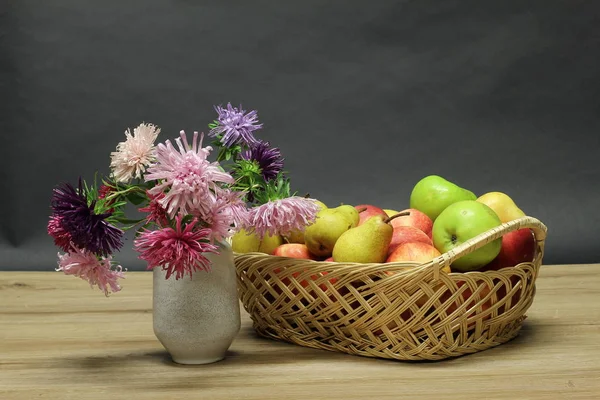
xmin=333 ymin=215 xmax=394 ymax=263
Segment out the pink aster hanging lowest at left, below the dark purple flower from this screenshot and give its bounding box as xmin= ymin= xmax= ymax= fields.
xmin=56 ymin=247 xmax=125 ymax=296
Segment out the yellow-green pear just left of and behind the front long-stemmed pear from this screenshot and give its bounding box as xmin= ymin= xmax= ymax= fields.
xmin=304 ymin=205 xmax=359 ymax=257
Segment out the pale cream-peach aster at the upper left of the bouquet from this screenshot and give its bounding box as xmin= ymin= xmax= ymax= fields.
xmin=110 ymin=123 xmax=160 ymax=183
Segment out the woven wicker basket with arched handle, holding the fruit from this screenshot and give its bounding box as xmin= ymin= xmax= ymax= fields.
xmin=235 ymin=217 xmax=547 ymax=360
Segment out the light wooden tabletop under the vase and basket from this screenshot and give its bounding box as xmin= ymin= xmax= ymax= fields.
xmin=0 ymin=264 xmax=600 ymax=400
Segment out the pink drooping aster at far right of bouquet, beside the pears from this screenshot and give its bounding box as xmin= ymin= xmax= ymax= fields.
xmin=247 ymin=196 xmax=319 ymax=238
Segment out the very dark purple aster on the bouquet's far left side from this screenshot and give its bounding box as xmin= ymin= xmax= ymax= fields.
xmin=51 ymin=179 xmax=123 ymax=256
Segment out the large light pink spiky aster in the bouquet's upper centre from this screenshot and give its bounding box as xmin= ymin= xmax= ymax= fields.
xmin=146 ymin=131 xmax=234 ymax=218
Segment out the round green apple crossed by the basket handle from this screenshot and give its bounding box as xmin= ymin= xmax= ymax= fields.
xmin=432 ymin=200 xmax=502 ymax=272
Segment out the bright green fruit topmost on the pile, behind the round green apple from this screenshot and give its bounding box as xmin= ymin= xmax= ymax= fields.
xmin=410 ymin=175 xmax=477 ymax=221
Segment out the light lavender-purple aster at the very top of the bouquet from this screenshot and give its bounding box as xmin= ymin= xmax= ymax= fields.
xmin=209 ymin=103 xmax=262 ymax=147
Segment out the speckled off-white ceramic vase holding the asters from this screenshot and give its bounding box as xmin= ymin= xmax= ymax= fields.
xmin=152 ymin=243 xmax=240 ymax=364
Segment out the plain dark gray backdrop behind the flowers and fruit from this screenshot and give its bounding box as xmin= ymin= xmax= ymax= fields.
xmin=0 ymin=0 xmax=600 ymax=270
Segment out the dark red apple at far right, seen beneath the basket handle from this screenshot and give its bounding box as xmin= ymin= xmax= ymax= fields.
xmin=482 ymin=228 xmax=535 ymax=271
